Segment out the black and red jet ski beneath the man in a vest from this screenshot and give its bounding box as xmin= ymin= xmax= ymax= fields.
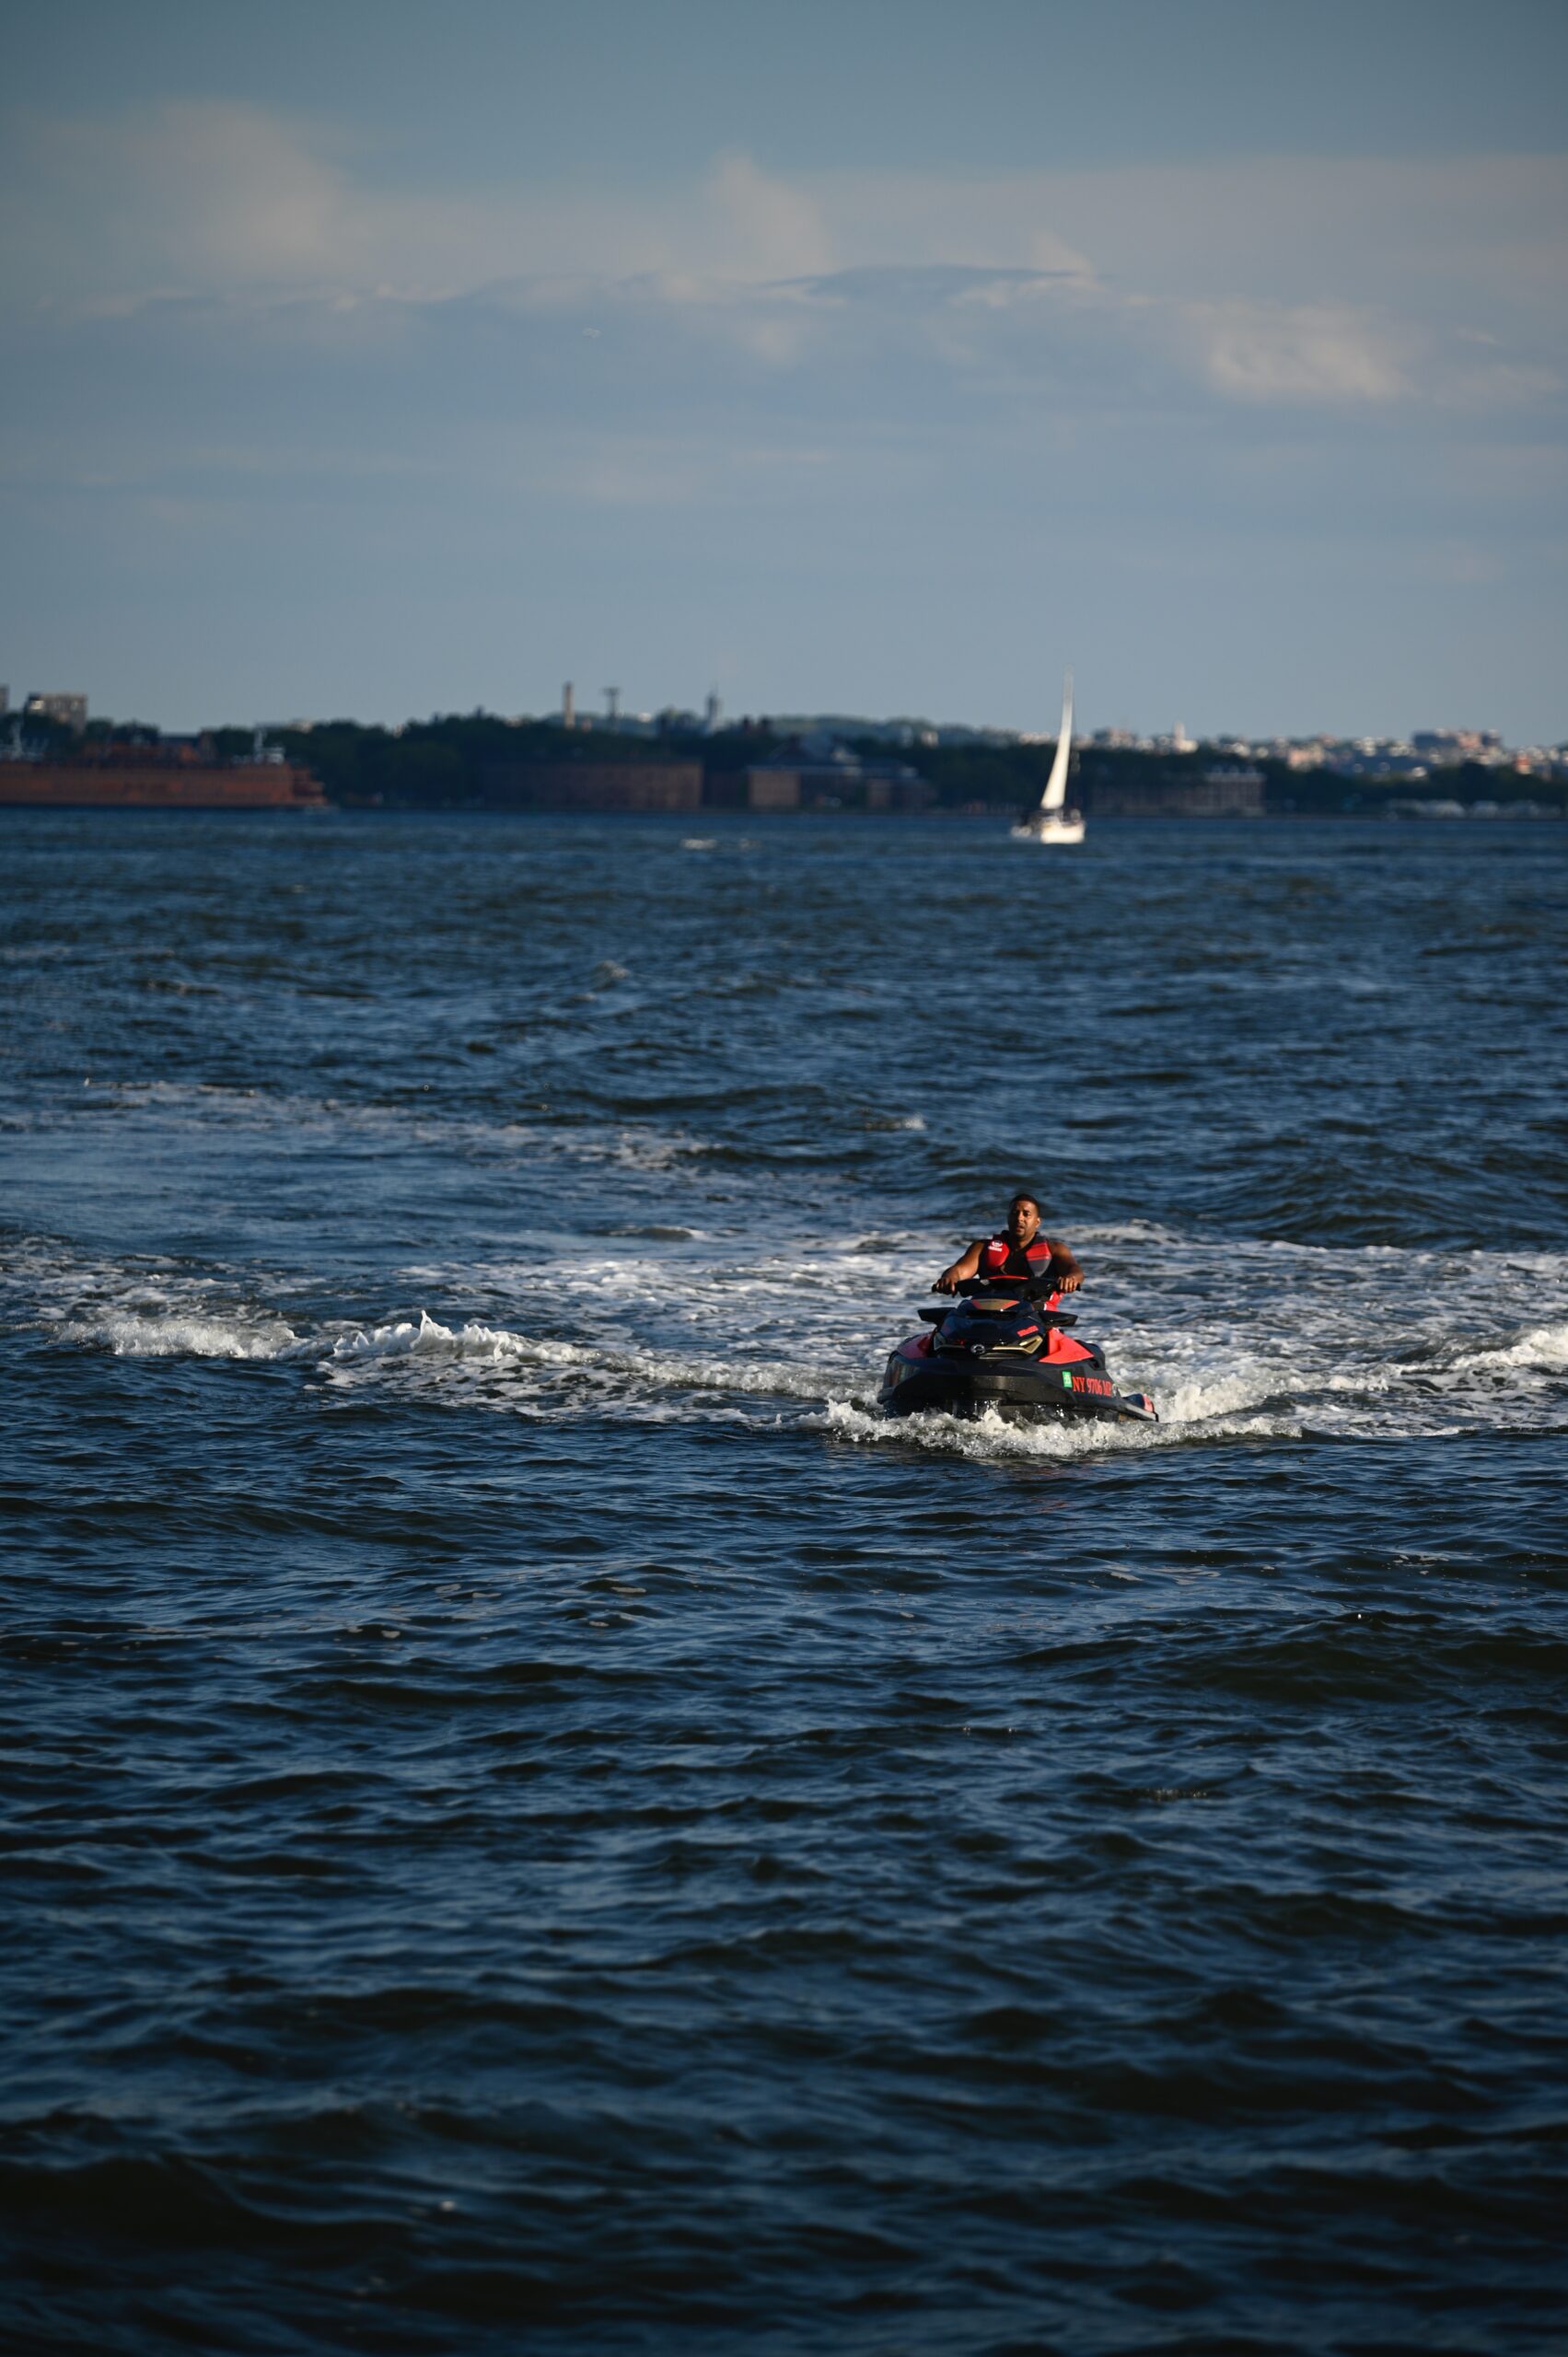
xmin=877 ymin=1278 xmax=1160 ymax=1423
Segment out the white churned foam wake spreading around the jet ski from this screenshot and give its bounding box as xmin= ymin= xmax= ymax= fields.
xmin=15 ymin=1228 xmax=1568 ymax=1457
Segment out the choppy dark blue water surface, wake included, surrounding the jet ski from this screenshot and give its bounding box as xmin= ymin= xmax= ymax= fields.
xmin=0 ymin=813 xmax=1568 ymax=2357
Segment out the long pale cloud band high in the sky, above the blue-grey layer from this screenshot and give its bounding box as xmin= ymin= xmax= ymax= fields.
xmin=3 ymin=99 xmax=1568 ymax=325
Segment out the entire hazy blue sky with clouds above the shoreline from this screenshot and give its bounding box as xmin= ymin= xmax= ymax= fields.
xmin=0 ymin=0 xmax=1568 ymax=742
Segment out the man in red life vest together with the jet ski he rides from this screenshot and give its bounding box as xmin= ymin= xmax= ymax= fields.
xmin=877 ymin=1195 xmax=1157 ymax=1423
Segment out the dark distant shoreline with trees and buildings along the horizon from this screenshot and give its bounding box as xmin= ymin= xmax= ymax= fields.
xmin=0 ymin=712 xmax=1568 ymax=825
